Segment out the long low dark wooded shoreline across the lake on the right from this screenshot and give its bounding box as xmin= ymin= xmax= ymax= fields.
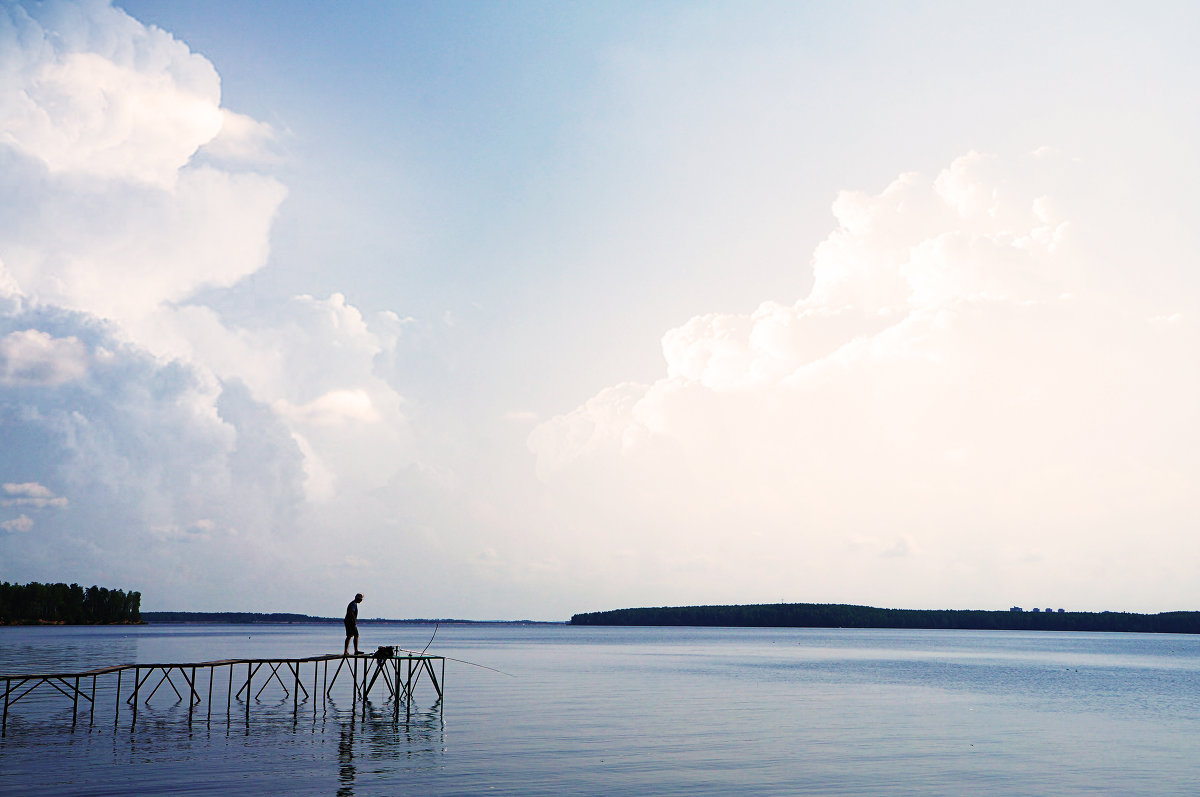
xmin=571 ymin=604 xmax=1200 ymax=634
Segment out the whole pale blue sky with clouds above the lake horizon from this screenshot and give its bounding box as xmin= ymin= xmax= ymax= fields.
xmin=0 ymin=0 xmax=1200 ymax=621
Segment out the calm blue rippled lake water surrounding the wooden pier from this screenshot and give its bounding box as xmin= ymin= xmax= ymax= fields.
xmin=0 ymin=623 xmax=1200 ymax=796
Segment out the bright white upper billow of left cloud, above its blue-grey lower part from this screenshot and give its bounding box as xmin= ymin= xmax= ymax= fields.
xmin=0 ymin=1 xmax=287 ymax=328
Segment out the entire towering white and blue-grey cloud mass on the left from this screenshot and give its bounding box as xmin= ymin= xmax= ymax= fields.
xmin=0 ymin=0 xmax=413 ymax=607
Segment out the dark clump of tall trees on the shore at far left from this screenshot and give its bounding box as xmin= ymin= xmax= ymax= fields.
xmin=0 ymin=581 xmax=142 ymax=625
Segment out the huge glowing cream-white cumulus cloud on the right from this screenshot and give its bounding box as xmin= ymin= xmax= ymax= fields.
xmin=528 ymin=152 xmax=1200 ymax=609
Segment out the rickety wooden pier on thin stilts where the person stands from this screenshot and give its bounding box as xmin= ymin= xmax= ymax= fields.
xmin=0 ymin=648 xmax=445 ymax=733
